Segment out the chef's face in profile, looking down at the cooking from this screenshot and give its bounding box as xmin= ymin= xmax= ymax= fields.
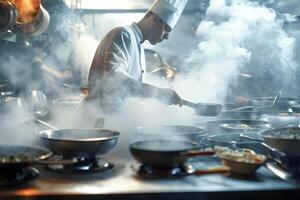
xmin=149 ymin=17 xmax=171 ymax=45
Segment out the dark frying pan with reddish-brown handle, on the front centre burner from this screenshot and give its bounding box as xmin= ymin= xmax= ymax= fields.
xmin=129 ymin=140 xmax=214 ymax=169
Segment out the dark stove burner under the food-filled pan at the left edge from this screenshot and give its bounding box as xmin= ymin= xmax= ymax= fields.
xmin=0 ymin=167 xmax=39 ymax=186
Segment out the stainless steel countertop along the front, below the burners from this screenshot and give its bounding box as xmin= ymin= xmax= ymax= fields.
xmin=0 ymin=155 xmax=300 ymax=199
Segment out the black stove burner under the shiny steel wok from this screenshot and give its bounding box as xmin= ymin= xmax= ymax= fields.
xmin=46 ymin=157 xmax=114 ymax=172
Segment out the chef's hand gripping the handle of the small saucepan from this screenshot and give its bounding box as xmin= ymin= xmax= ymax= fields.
xmin=157 ymin=88 xmax=183 ymax=107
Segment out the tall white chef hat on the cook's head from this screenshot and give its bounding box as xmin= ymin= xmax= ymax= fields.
xmin=149 ymin=0 xmax=188 ymax=29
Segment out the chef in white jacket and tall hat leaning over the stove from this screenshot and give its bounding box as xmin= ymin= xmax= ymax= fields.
xmin=88 ymin=0 xmax=187 ymax=113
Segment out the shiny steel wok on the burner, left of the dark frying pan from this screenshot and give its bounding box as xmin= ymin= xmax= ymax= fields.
xmin=38 ymin=129 xmax=120 ymax=159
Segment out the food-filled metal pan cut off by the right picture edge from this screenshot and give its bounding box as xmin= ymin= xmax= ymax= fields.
xmin=260 ymin=127 xmax=300 ymax=156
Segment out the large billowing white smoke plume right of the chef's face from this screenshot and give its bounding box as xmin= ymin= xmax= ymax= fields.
xmin=166 ymin=0 xmax=296 ymax=102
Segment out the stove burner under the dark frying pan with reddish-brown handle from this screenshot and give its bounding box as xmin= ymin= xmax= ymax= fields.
xmin=132 ymin=164 xmax=195 ymax=178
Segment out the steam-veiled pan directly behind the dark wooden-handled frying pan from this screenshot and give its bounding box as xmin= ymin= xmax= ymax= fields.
xmin=136 ymin=125 xmax=205 ymax=142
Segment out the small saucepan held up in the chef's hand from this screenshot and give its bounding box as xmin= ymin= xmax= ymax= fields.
xmin=182 ymin=99 xmax=222 ymax=116
